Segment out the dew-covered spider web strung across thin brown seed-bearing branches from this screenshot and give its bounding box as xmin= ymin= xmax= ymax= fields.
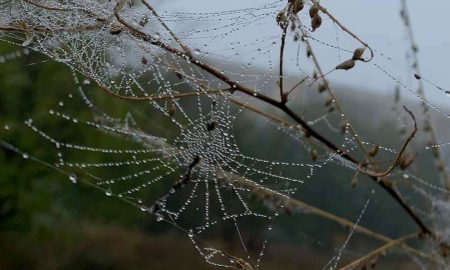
xmin=0 ymin=0 xmax=450 ymax=270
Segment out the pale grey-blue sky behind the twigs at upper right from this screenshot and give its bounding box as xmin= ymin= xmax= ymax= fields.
xmin=159 ymin=0 xmax=450 ymax=104
